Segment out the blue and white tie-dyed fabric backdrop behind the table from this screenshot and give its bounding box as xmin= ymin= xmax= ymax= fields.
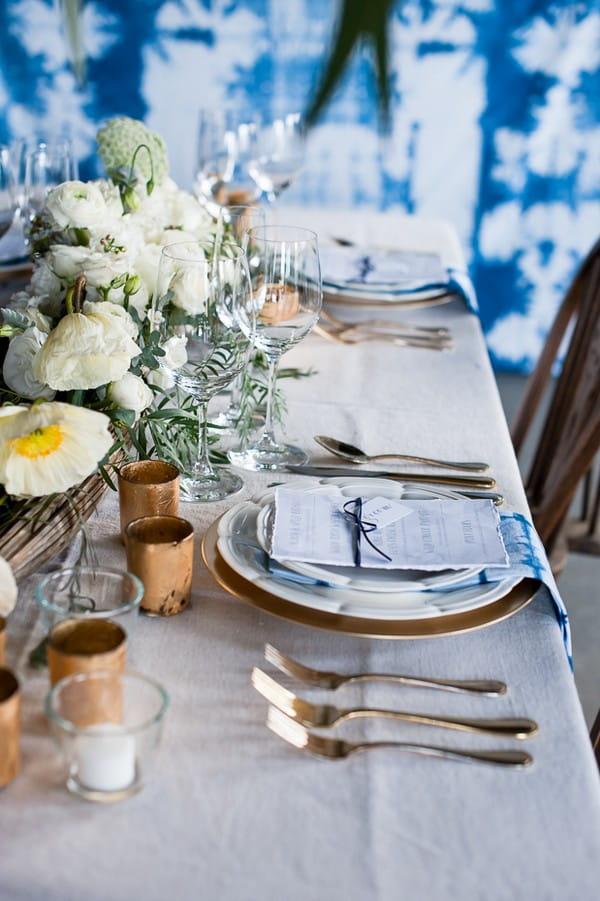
xmin=0 ymin=0 xmax=600 ymax=370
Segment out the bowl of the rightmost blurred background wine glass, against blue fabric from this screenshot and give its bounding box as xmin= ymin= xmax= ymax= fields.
xmin=248 ymin=113 xmax=305 ymax=202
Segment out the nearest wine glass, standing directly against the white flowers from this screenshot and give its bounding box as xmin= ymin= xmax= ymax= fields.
xmin=151 ymin=241 xmax=255 ymax=501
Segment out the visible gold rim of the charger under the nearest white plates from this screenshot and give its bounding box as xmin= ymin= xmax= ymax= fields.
xmin=202 ymin=519 xmax=541 ymax=638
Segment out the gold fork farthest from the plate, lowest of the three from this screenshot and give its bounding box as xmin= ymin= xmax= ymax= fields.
xmin=267 ymin=707 xmax=533 ymax=767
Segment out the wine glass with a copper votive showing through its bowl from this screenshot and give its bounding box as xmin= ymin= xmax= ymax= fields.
xmin=229 ymin=225 xmax=322 ymax=470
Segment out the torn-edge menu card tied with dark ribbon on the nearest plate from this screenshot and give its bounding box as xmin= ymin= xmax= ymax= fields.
xmin=270 ymin=486 xmax=509 ymax=571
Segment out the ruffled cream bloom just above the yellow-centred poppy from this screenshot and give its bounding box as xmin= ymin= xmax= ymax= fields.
xmin=35 ymin=313 xmax=140 ymax=391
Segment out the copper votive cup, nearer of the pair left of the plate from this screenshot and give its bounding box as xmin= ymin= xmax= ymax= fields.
xmin=125 ymin=516 xmax=194 ymax=616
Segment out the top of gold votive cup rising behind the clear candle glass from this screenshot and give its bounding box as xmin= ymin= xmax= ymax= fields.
xmin=47 ymin=619 xmax=127 ymax=685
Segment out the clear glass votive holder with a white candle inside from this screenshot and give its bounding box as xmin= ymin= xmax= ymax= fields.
xmin=46 ymin=671 xmax=169 ymax=802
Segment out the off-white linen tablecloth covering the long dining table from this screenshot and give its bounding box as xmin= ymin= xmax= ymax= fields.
xmin=0 ymin=217 xmax=600 ymax=901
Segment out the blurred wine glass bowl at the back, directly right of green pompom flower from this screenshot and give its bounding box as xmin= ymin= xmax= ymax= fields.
xmin=196 ymin=110 xmax=260 ymax=216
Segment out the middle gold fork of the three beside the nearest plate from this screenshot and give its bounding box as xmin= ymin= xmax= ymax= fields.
xmin=252 ymin=666 xmax=538 ymax=738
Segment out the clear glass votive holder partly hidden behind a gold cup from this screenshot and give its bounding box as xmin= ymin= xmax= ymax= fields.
xmin=35 ymin=566 xmax=144 ymax=638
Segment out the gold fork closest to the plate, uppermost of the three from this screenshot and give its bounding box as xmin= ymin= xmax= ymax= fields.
xmin=265 ymin=644 xmax=506 ymax=697
